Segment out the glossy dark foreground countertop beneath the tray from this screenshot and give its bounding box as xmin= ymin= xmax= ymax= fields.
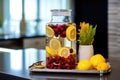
xmin=0 ymin=48 xmax=120 ymax=80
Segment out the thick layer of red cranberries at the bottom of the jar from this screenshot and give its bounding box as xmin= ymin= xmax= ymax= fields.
xmin=47 ymin=54 xmax=76 ymax=69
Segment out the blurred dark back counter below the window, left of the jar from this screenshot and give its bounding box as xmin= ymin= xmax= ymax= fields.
xmin=0 ymin=34 xmax=45 ymax=49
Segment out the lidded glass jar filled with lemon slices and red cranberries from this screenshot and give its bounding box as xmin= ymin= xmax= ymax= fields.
xmin=46 ymin=9 xmax=76 ymax=69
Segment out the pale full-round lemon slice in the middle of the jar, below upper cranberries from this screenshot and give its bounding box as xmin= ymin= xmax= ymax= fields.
xmin=49 ymin=38 xmax=61 ymax=51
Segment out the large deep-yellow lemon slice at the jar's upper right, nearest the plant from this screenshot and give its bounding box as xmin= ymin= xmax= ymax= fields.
xmin=66 ymin=25 xmax=76 ymax=41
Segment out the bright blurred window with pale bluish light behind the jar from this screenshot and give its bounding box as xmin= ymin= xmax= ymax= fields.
xmin=0 ymin=0 xmax=71 ymax=35
